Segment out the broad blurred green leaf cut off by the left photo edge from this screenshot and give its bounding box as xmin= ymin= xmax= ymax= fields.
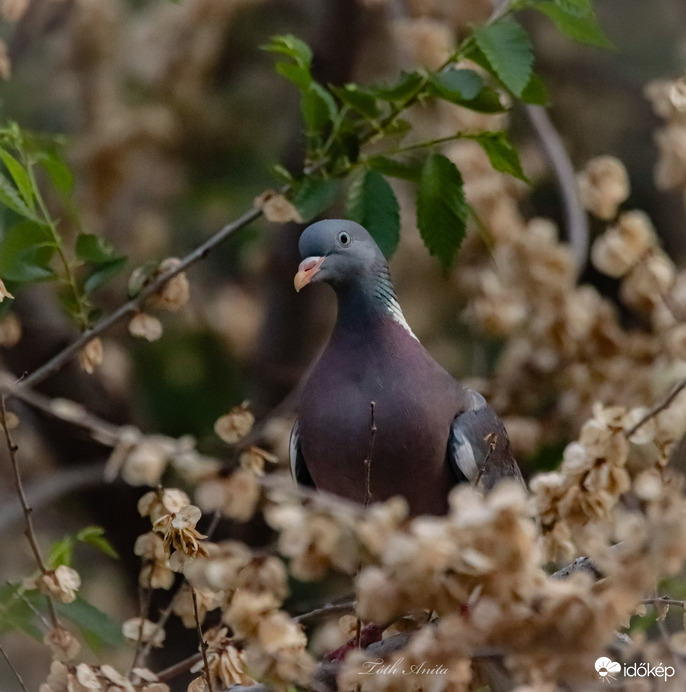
xmin=0 ymin=220 xmax=55 ymax=283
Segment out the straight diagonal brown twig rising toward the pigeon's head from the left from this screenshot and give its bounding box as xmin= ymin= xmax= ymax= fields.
xmin=18 ymin=203 xmax=262 ymax=389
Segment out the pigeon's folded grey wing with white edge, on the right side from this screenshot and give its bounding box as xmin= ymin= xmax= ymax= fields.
xmin=448 ymin=390 xmax=525 ymax=490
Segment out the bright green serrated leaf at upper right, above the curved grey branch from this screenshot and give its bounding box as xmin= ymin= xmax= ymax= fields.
xmin=474 ymin=18 xmax=534 ymax=96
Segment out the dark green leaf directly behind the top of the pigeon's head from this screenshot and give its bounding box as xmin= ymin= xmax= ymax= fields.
xmin=345 ymin=170 xmax=400 ymax=258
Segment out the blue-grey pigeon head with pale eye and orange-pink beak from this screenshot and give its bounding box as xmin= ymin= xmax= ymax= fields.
xmin=294 ymin=219 xmax=387 ymax=291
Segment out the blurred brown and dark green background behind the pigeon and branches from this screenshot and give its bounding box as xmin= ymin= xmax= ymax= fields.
xmin=0 ymin=0 xmax=686 ymax=689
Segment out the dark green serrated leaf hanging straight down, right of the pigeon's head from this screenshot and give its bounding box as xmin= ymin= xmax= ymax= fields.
xmin=417 ymin=154 xmax=467 ymax=270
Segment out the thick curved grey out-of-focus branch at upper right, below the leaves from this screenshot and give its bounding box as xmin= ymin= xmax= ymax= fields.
xmin=524 ymin=105 xmax=588 ymax=271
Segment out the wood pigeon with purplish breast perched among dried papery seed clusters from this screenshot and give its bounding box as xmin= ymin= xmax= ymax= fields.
xmin=290 ymin=219 xmax=524 ymax=515
